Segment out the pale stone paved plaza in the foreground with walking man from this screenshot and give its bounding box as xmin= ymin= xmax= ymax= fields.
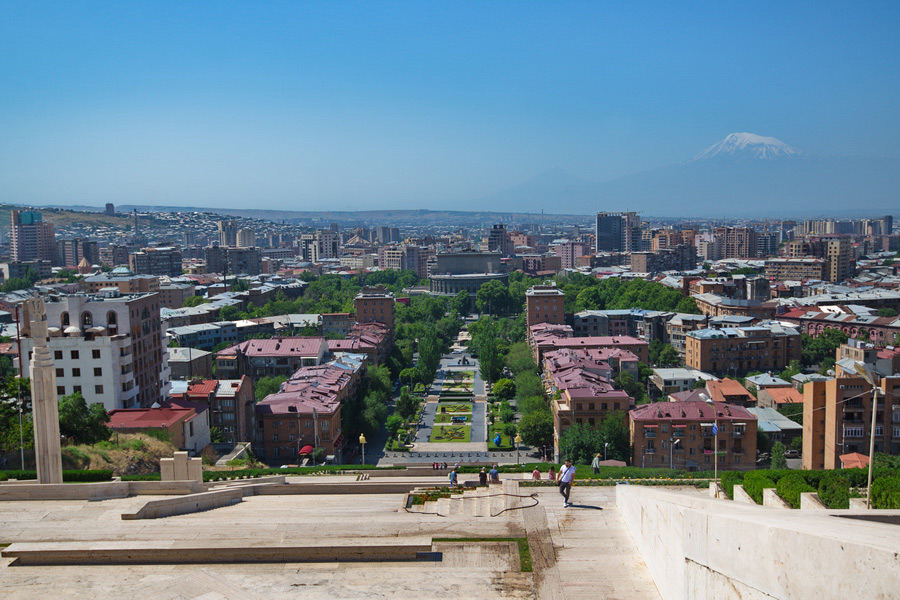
xmin=0 ymin=476 xmax=658 ymax=600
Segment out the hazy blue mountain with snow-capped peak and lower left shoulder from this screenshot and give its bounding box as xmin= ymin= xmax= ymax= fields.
xmin=468 ymin=133 xmax=900 ymax=218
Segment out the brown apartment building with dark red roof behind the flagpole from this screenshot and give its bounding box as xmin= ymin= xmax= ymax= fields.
xmin=629 ymin=401 xmax=757 ymax=471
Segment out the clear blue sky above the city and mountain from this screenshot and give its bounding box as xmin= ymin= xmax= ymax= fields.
xmin=0 ymin=0 xmax=900 ymax=210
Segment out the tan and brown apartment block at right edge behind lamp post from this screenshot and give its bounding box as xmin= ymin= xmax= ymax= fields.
xmin=803 ymin=376 xmax=900 ymax=469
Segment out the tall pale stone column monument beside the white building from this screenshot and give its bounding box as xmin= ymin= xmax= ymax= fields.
xmin=25 ymin=298 xmax=62 ymax=483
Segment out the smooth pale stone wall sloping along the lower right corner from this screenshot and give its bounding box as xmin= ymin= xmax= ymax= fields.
xmin=616 ymin=486 xmax=900 ymax=600
